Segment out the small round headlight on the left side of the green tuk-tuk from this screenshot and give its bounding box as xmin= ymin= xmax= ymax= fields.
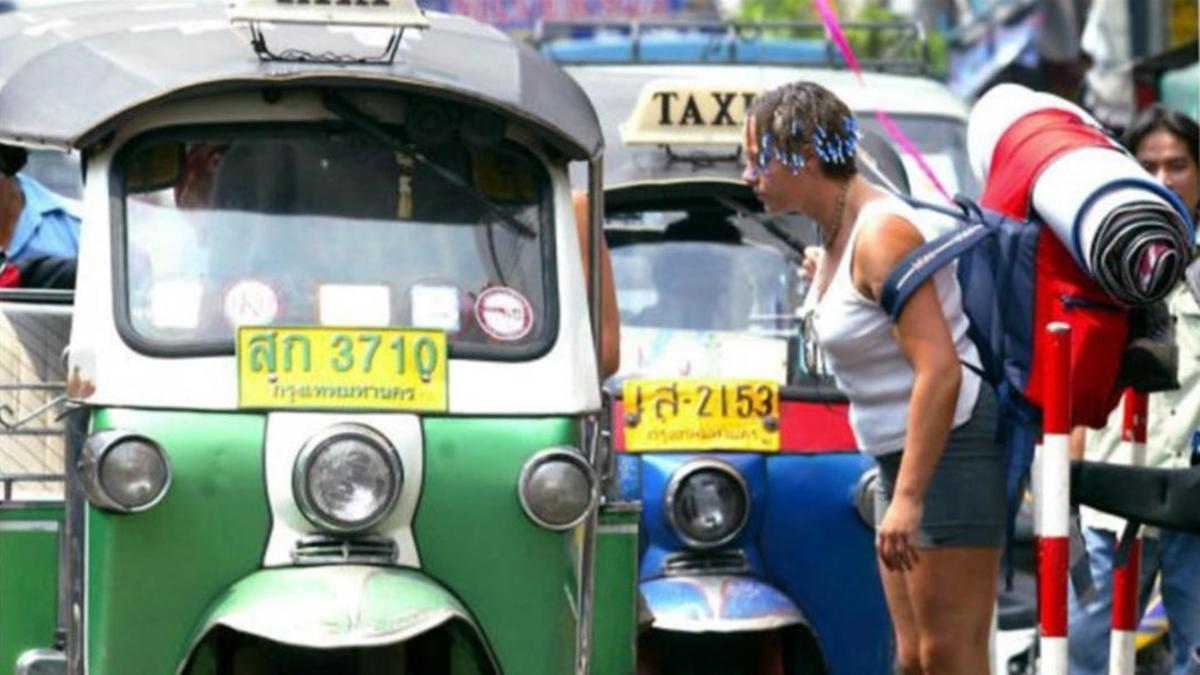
xmin=79 ymin=431 xmax=170 ymax=513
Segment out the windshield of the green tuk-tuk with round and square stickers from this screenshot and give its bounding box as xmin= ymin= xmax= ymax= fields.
xmin=118 ymin=127 xmax=553 ymax=356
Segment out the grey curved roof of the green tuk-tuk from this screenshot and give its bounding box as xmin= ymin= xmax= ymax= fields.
xmin=0 ymin=0 xmax=604 ymax=160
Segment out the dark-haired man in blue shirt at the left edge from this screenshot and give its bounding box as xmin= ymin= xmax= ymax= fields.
xmin=0 ymin=145 xmax=79 ymax=263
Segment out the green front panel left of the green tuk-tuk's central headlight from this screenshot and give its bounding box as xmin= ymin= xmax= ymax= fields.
xmin=86 ymin=410 xmax=270 ymax=675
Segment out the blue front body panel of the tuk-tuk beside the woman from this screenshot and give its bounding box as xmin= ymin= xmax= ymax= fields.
xmin=638 ymin=453 xmax=892 ymax=675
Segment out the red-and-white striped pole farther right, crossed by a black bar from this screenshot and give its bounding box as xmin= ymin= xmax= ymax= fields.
xmin=1109 ymin=389 xmax=1147 ymax=675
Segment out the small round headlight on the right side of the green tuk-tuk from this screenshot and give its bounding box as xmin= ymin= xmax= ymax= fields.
xmin=517 ymin=448 xmax=599 ymax=530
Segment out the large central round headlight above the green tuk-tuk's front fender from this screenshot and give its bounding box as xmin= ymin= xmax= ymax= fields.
xmin=292 ymin=424 xmax=403 ymax=533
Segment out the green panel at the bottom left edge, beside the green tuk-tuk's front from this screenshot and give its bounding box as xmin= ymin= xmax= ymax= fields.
xmin=0 ymin=504 xmax=62 ymax=673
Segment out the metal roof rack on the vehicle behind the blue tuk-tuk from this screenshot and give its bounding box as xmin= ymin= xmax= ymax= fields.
xmin=532 ymin=18 xmax=931 ymax=73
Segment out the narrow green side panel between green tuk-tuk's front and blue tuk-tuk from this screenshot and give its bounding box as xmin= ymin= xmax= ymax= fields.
xmin=592 ymin=502 xmax=642 ymax=675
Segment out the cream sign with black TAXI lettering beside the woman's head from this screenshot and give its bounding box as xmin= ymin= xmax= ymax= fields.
xmin=620 ymin=79 xmax=762 ymax=145
